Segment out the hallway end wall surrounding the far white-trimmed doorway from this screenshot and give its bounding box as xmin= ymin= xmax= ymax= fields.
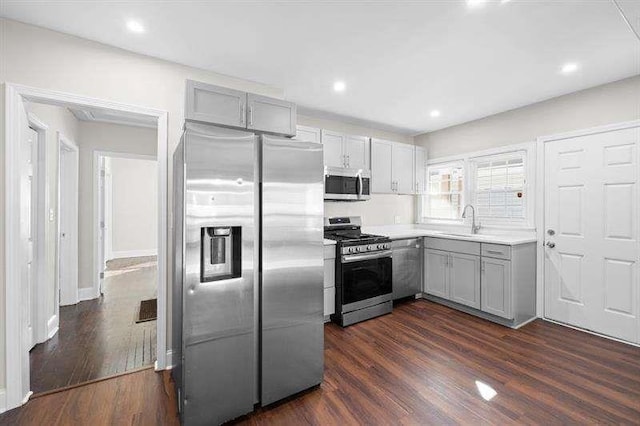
xmin=78 ymin=121 xmax=157 ymax=288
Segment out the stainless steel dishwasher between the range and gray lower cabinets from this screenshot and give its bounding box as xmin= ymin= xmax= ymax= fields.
xmin=391 ymin=238 xmax=423 ymax=300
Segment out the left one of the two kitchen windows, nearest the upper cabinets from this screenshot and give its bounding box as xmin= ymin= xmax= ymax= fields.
xmin=424 ymin=163 xmax=464 ymax=219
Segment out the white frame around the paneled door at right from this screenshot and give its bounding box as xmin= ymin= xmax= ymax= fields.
xmin=535 ymin=120 xmax=640 ymax=328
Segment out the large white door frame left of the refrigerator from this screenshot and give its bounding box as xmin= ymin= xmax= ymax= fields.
xmin=1 ymin=82 xmax=168 ymax=410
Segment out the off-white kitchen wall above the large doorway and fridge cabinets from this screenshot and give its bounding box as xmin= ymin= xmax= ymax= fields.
xmin=0 ymin=18 xmax=283 ymax=389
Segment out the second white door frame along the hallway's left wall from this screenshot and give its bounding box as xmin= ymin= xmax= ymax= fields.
xmin=57 ymin=132 xmax=80 ymax=306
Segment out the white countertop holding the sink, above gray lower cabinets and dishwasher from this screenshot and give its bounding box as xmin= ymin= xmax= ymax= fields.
xmin=362 ymin=225 xmax=537 ymax=246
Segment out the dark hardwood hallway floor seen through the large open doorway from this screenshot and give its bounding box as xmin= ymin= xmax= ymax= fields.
xmin=30 ymin=256 xmax=157 ymax=394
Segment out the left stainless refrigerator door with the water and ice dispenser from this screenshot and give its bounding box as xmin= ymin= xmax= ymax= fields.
xmin=181 ymin=124 xmax=258 ymax=425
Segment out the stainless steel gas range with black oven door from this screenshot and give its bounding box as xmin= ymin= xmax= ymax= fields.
xmin=324 ymin=217 xmax=393 ymax=327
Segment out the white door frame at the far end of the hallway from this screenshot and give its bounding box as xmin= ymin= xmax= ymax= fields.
xmin=92 ymin=151 xmax=160 ymax=297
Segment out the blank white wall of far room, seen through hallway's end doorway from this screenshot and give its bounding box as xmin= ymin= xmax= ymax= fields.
xmin=110 ymin=157 xmax=158 ymax=258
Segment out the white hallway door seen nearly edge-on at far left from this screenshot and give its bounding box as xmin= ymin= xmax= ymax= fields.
xmin=20 ymin=105 xmax=38 ymax=350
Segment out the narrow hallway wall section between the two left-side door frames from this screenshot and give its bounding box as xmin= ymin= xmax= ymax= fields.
xmin=25 ymin=103 xmax=79 ymax=334
